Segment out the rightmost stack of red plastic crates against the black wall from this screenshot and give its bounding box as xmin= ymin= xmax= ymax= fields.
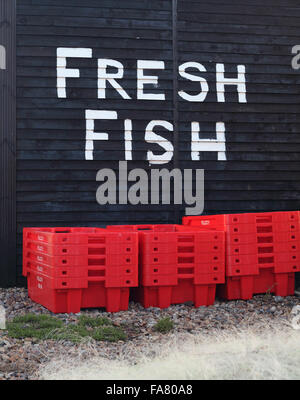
xmin=183 ymin=211 xmax=300 ymax=300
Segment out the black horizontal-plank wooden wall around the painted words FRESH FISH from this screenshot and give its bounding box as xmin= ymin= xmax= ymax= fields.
xmin=12 ymin=0 xmax=300 ymax=283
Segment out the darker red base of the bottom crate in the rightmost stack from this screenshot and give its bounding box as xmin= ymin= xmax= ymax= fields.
xmin=217 ymin=268 xmax=295 ymax=300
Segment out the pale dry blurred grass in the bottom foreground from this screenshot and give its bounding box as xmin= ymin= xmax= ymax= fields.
xmin=37 ymin=322 xmax=300 ymax=380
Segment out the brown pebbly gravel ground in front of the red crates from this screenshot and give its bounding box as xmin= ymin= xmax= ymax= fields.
xmin=0 ymin=288 xmax=300 ymax=380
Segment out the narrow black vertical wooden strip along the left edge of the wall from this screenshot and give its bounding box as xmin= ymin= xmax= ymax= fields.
xmin=0 ymin=0 xmax=16 ymax=286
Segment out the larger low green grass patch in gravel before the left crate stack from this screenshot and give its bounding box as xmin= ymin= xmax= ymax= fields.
xmin=7 ymin=314 xmax=127 ymax=343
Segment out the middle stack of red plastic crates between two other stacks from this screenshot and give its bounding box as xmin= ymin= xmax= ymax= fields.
xmin=107 ymin=225 xmax=225 ymax=308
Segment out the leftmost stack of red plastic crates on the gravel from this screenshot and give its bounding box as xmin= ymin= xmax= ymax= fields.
xmin=23 ymin=228 xmax=138 ymax=313
